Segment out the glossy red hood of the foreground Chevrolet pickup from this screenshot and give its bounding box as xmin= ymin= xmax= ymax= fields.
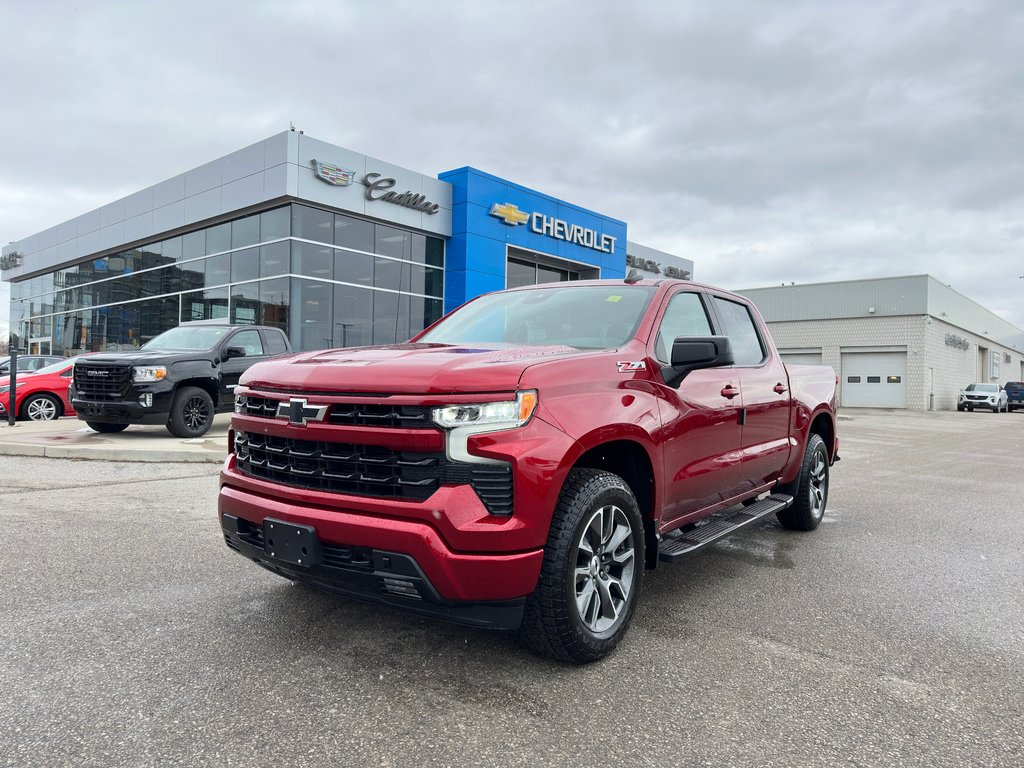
xmin=242 ymin=344 xmax=593 ymax=394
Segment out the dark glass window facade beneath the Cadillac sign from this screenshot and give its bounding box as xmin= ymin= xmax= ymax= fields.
xmin=11 ymin=203 xmax=444 ymax=355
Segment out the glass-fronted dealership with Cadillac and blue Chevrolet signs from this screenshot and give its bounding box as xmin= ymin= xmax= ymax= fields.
xmin=0 ymin=130 xmax=693 ymax=355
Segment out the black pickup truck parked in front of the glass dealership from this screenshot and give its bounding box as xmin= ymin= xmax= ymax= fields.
xmin=69 ymin=321 xmax=292 ymax=437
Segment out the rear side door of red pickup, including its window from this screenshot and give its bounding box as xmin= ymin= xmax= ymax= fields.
xmin=712 ymin=296 xmax=792 ymax=490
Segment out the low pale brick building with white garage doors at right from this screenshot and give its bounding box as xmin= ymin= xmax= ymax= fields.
xmin=738 ymin=274 xmax=1024 ymax=411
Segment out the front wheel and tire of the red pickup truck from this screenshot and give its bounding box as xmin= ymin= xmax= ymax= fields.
xmin=520 ymin=469 xmax=644 ymax=663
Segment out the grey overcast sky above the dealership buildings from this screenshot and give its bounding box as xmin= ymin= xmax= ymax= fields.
xmin=0 ymin=0 xmax=1024 ymax=339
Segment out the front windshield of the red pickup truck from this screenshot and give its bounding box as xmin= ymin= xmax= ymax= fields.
xmin=419 ymin=285 xmax=654 ymax=349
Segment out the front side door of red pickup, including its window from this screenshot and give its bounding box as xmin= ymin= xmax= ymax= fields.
xmin=648 ymin=289 xmax=742 ymax=526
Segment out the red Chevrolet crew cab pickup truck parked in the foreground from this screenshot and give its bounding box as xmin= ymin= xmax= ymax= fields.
xmin=218 ymin=279 xmax=839 ymax=663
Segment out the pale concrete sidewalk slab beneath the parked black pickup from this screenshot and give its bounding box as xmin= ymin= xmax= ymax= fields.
xmin=0 ymin=414 xmax=231 ymax=464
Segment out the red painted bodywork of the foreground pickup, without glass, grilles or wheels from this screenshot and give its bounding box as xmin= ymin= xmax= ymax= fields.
xmin=214 ymin=281 xmax=838 ymax=600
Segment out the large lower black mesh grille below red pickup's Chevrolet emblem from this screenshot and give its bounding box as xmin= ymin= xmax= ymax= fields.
xmin=234 ymin=432 xmax=512 ymax=515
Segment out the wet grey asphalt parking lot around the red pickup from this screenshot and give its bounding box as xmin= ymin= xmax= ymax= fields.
xmin=0 ymin=411 xmax=1024 ymax=767
